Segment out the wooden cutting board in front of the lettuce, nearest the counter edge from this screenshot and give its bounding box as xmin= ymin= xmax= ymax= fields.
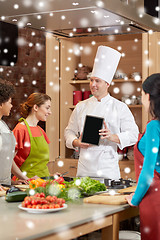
xmin=83 ymin=194 xmax=128 ymax=205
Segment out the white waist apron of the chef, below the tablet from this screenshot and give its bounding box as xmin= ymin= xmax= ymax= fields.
xmin=77 ymin=145 xmax=120 ymax=180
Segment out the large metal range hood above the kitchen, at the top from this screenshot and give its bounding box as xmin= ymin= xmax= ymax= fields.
xmin=0 ymin=0 xmax=160 ymax=37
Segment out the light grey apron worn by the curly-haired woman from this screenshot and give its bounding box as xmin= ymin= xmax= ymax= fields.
xmin=0 ymin=120 xmax=16 ymax=185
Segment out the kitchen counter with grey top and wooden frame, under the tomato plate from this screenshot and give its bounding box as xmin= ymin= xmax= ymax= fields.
xmin=0 ymin=197 xmax=138 ymax=240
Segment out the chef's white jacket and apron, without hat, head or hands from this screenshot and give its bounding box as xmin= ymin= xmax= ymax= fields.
xmin=65 ymin=94 xmax=139 ymax=180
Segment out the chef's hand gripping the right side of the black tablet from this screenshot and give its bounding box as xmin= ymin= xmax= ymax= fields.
xmin=99 ymin=121 xmax=120 ymax=144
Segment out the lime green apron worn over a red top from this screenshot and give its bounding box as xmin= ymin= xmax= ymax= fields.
xmin=19 ymin=118 xmax=49 ymax=178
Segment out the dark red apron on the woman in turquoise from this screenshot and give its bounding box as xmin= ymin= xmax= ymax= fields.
xmin=134 ymin=134 xmax=160 ymax=240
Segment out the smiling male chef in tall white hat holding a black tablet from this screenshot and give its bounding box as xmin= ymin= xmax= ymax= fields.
xmin=65 ymin=46 xmax=139 ymax=180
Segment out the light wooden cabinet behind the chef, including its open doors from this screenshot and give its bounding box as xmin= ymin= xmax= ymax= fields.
xmin=46 ymin=33 xmax=160 ymax=177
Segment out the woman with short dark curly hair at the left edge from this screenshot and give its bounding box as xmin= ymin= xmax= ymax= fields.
xmin=0 ymin=79 xmax=28 ymax=188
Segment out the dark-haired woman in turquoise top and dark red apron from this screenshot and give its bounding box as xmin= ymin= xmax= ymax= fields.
xmin=126 ymin=73 xmax=160 ymax=240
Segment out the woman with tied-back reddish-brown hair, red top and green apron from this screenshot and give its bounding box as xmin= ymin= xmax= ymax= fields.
xmin=13 ymin=93 xmax=51 ymax=178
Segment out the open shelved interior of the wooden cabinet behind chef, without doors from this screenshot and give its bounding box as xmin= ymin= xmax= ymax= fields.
xmin=60 ymin=34 xmax=143 ymax=158
